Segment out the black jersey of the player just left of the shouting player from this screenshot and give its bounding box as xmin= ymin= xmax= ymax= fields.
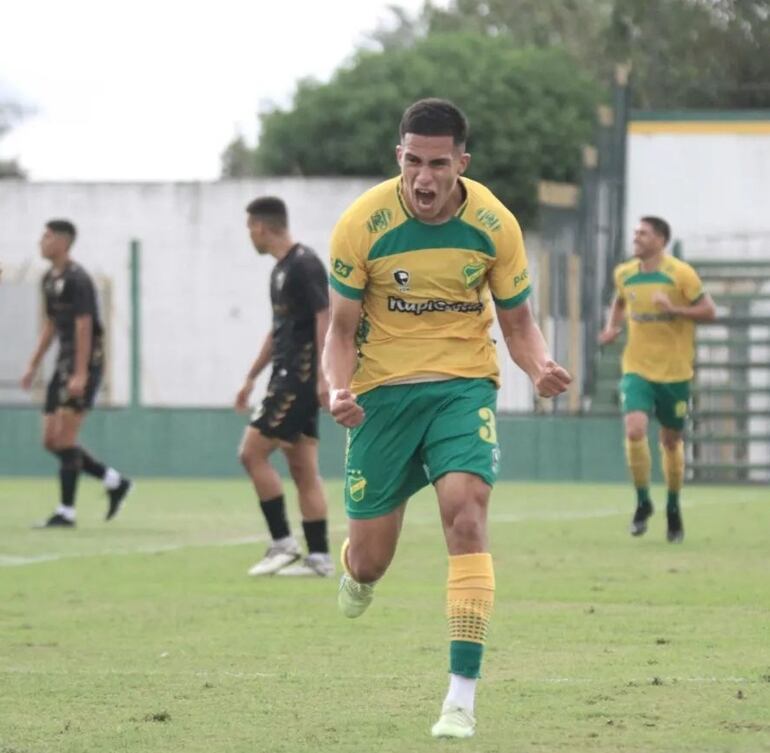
xmin=270 ymin=243 xmax=329 ymax=382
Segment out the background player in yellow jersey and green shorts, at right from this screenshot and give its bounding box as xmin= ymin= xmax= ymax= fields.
xmin=599 ymin=217 xmax=716 ymax=543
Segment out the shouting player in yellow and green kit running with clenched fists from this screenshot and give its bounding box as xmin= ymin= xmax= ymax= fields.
xmin=323 ymin=99 xmax=570 ymax=737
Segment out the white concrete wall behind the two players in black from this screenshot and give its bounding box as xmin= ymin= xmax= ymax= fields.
xmin=0 ymin=178 xmax=532 ymax=410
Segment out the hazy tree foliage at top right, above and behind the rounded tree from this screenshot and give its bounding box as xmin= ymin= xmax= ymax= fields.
xmin=408 ymin=0 xmax=770 ymax=109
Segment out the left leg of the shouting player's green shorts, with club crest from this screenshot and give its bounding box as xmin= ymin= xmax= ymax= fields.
xmin=345 ymin=385 xmax=429 ymax=519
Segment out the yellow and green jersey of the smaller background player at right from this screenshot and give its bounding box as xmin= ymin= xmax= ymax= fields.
xmin=614 ymin=256 xmax=703 ymax=382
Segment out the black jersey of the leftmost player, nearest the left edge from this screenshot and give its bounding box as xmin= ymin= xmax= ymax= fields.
xmin=43 ymin=262 xmax=104 ymax=366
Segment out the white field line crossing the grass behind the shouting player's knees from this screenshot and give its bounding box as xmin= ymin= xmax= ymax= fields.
xmin=0 ymin=490 xmax=754 ymax=567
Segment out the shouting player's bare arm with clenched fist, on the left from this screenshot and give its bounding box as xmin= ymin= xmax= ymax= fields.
xmin=323 ymin=290 xmax=364 ymax=429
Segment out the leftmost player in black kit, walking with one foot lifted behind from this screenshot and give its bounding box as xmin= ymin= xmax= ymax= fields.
xmin=21 ymin=220 xmax=131 ymax=528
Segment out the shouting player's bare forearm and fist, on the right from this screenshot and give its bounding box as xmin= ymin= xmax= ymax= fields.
xmin=497 ymin=301 xmax=572 ymax=397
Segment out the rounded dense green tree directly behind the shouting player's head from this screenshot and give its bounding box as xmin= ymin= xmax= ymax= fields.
xmin=249 ymin=32 xmax=599 ymax=220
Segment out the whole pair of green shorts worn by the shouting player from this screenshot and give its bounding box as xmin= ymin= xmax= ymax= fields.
xmin=345 ymin=379 xmax=500 ymax=518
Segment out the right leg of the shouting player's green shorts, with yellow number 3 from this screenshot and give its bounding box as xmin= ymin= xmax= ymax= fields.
xmin=422 ymin=379 xmax=500 ymax=487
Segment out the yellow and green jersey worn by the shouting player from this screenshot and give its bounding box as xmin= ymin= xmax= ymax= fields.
xmin=329 ymin=177 xmax=530 ymax=394
